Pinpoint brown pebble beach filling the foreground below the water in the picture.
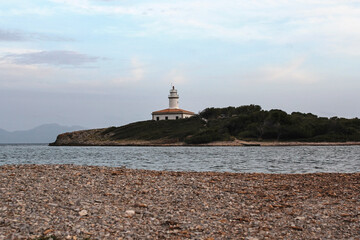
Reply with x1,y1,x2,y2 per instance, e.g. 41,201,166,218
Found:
0,165,360,240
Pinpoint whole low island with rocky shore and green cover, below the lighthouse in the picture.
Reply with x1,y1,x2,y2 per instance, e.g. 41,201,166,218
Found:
49,105,360,146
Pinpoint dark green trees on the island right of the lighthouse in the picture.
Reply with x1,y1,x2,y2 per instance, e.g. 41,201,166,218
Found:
185,105,360,144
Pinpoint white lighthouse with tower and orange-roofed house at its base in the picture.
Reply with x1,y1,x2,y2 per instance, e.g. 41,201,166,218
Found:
152,86,195,121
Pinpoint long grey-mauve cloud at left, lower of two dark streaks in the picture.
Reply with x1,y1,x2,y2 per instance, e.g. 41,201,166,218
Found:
3,51,100,67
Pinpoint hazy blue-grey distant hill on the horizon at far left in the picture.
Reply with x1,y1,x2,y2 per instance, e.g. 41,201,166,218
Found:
0,124,84,144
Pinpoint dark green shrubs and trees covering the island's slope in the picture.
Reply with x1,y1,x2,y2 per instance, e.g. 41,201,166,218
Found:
100,105,360,144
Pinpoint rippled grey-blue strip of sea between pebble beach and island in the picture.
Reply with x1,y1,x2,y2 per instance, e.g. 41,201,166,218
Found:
0,145,360,173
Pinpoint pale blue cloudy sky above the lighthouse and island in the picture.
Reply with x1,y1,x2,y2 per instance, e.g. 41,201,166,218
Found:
0,0,360,131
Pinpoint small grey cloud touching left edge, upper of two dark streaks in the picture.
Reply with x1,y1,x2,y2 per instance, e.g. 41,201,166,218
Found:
0,29,73,42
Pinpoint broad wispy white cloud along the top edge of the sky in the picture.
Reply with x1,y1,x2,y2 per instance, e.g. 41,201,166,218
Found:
52,0,360,51
